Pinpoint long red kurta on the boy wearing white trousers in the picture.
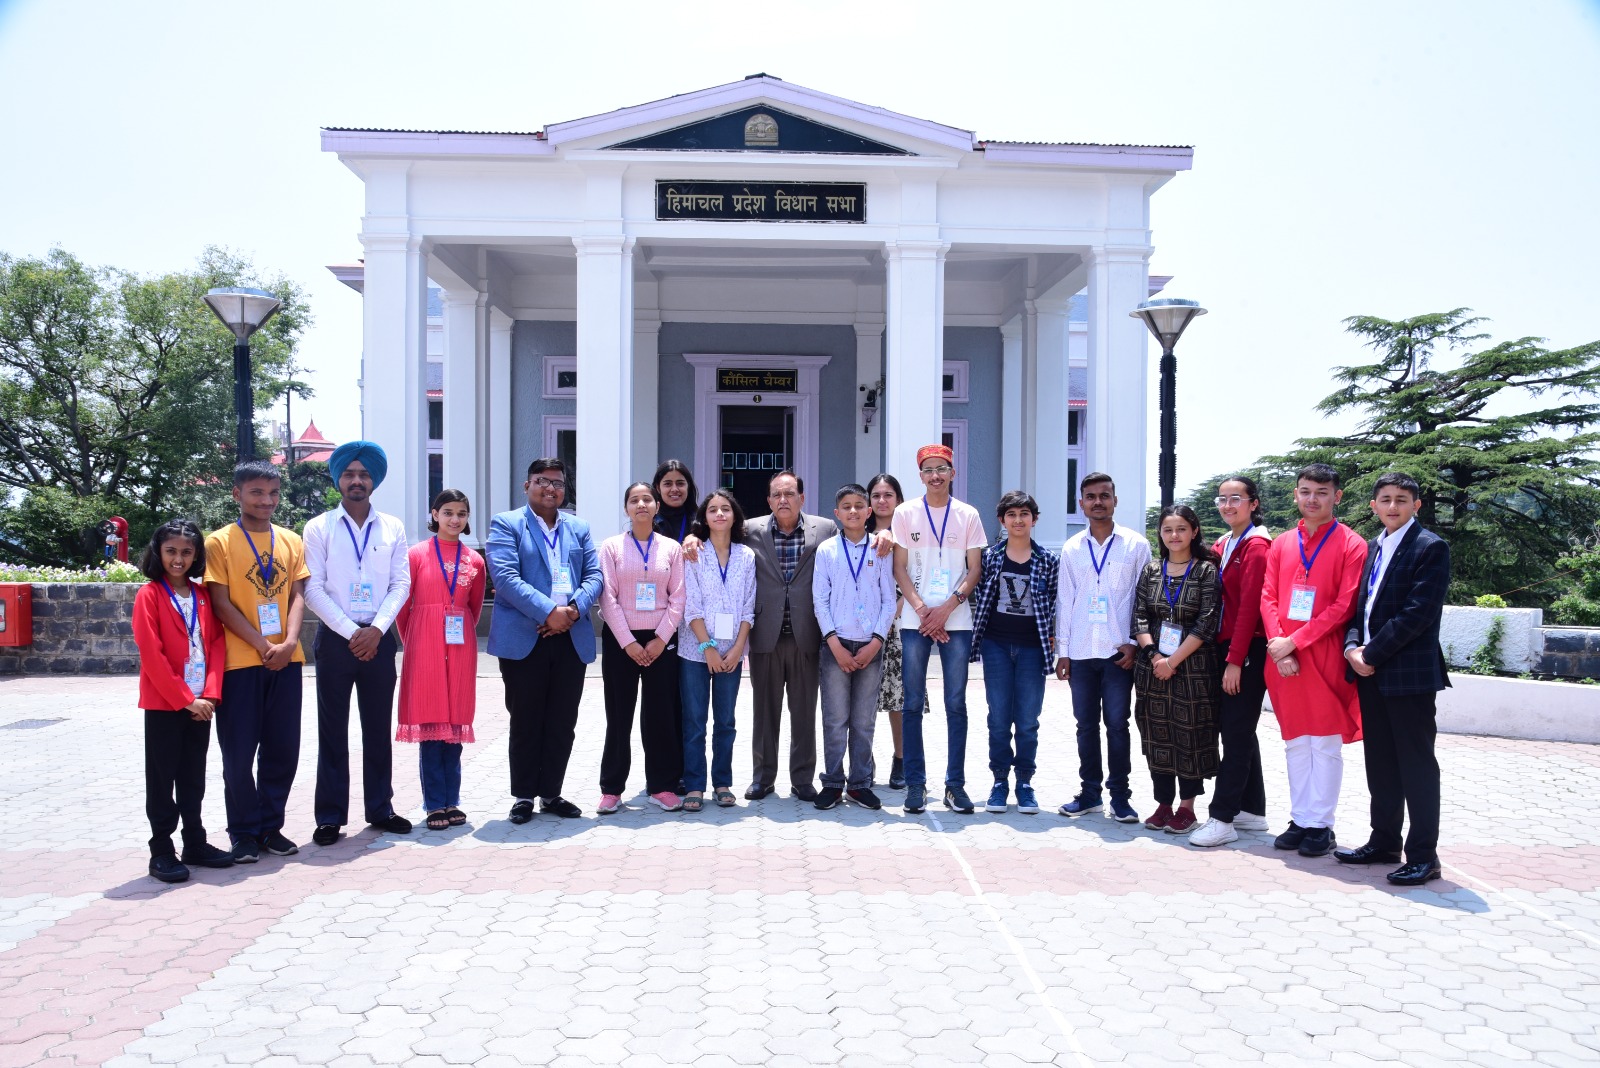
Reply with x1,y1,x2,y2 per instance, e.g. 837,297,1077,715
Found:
1261,521,1366,743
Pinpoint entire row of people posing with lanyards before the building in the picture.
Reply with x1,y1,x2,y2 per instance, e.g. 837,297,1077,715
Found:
134,441,1450,884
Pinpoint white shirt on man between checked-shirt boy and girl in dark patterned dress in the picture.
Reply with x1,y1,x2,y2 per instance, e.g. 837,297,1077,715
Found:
1056,523,1150,660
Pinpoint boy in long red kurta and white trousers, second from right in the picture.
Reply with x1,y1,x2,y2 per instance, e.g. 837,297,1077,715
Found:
1261,464,1366,857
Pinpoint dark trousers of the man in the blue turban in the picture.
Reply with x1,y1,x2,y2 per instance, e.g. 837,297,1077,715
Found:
312,625,395,827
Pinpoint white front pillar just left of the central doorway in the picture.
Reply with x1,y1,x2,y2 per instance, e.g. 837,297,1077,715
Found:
573,235,634,544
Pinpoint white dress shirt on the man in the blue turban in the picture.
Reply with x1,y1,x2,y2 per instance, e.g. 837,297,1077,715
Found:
301,504,411,638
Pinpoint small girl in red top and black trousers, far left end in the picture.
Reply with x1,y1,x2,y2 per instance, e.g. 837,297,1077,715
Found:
133,520,234,883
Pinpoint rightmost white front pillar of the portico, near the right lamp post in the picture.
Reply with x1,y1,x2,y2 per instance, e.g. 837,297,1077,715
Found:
1085,246,1155,531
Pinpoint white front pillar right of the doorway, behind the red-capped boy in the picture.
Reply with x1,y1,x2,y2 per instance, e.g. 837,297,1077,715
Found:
880,241,940,496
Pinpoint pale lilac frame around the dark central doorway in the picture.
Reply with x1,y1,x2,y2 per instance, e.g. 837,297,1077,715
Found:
683,352,832,494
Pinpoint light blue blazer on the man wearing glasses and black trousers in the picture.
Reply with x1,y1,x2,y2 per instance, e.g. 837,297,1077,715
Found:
485,505,600,664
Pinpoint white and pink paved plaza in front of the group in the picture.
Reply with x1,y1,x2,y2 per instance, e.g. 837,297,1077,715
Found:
0,671,1600,1068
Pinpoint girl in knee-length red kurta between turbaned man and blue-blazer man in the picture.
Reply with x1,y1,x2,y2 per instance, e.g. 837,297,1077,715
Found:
395,489,485,830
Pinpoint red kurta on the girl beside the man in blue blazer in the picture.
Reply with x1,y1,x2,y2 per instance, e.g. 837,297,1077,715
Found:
395,537,485,742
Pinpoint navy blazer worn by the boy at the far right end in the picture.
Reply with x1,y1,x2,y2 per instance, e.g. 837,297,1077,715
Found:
1344,523,1450,697
